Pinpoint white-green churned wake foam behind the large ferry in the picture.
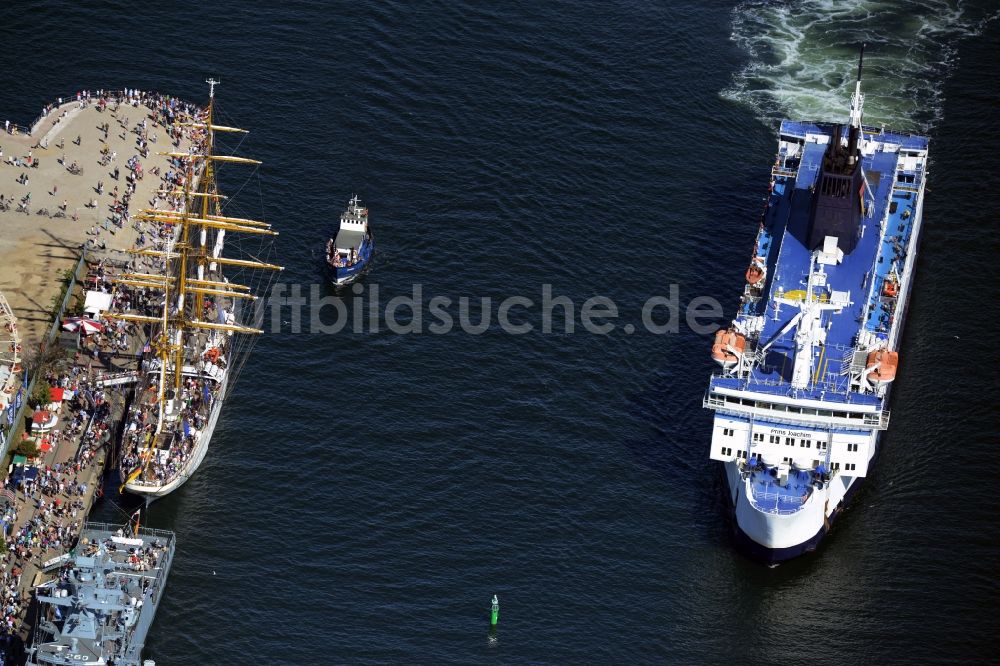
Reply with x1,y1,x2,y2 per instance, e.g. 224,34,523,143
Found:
722,0,1000,132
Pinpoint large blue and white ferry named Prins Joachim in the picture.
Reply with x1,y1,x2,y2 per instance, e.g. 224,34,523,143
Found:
704,49,928,564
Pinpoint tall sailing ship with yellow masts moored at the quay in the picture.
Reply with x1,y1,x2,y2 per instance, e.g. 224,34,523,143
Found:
109,79,282,502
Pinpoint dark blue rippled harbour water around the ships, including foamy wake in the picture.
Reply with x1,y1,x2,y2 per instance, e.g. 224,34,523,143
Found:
0,0,1000,666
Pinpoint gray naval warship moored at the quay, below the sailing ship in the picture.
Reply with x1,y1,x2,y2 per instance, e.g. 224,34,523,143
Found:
27,523,175,666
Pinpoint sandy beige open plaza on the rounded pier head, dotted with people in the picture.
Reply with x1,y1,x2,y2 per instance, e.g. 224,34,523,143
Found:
0,96,197,350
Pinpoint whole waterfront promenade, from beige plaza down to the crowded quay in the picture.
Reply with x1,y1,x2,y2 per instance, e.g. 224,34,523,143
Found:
0,94,201,652
